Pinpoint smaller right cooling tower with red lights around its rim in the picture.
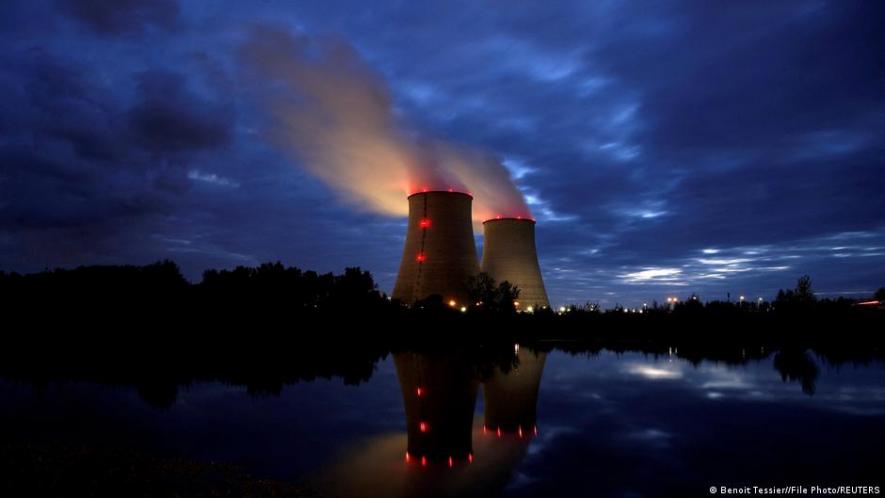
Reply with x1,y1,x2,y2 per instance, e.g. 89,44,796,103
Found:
482,218,550,309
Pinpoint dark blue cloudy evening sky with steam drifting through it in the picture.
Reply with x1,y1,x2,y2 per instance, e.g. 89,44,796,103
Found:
0,0,885,306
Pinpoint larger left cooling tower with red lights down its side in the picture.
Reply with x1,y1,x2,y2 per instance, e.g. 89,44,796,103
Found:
392,191,479,306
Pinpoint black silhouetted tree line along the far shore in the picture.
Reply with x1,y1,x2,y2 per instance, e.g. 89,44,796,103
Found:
0,260,885,323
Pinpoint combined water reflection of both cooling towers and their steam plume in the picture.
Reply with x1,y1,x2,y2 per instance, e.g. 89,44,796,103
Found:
320,347,547,497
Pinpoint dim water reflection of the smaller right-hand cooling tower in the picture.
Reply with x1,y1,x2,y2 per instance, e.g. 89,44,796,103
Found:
483,349,547,434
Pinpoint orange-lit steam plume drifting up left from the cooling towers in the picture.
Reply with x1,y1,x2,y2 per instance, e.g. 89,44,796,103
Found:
241,26,531,220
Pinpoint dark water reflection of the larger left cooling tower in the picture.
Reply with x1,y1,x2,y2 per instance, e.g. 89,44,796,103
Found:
393,353,479,462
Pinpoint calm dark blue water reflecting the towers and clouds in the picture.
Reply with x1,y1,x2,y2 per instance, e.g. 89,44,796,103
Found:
0,348,885,497
